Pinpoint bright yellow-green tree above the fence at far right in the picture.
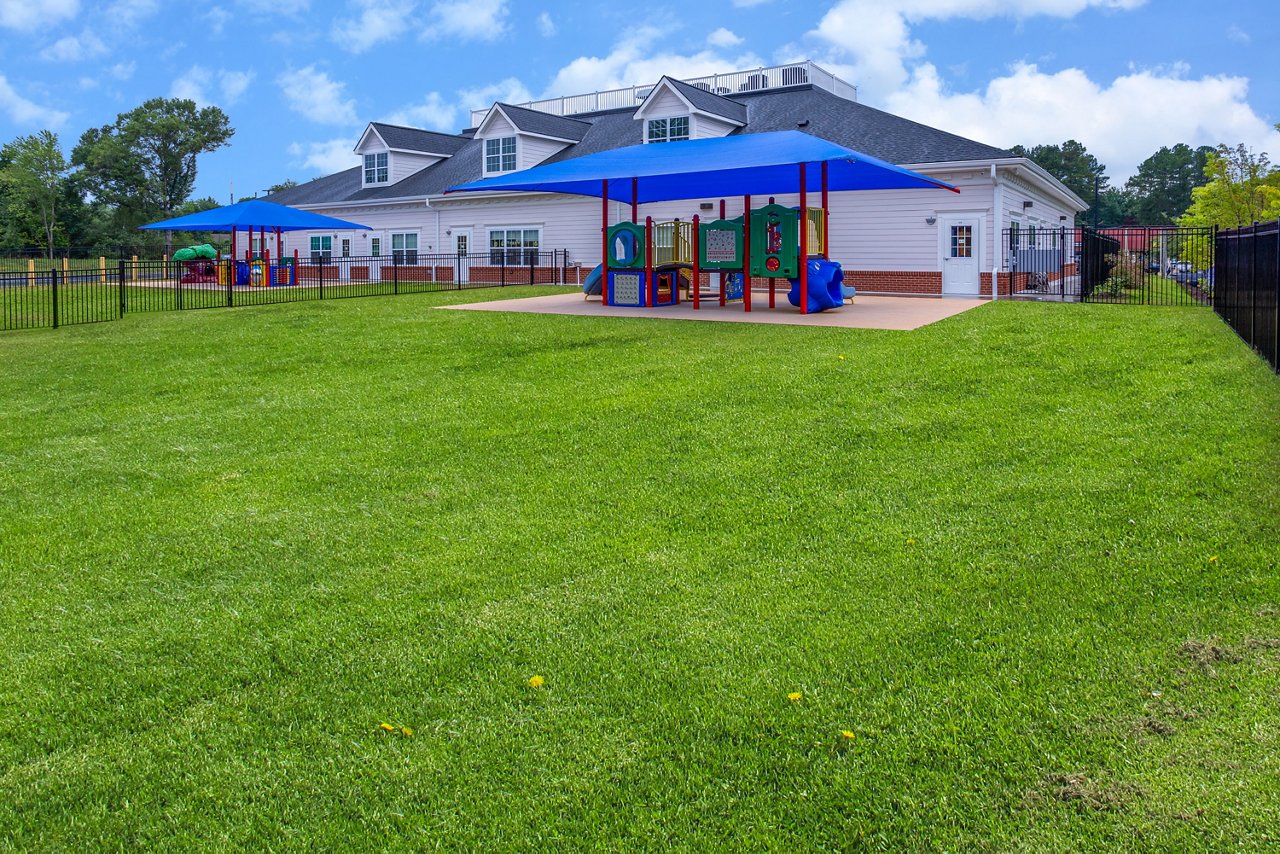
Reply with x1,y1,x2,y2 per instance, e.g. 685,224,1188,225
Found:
1178,143,1280,228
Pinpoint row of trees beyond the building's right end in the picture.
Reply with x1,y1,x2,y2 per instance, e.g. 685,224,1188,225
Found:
1011,125,1280,228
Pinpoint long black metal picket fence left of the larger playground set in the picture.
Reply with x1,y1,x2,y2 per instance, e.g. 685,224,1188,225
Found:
0,250,588,330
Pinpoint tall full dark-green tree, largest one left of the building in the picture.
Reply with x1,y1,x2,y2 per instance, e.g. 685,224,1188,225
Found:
72,97,236,248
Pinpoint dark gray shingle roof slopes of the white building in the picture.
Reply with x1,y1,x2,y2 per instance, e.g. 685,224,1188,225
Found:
268,83,1015,205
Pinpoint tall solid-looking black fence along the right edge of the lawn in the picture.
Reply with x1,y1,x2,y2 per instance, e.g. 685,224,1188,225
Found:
1213,220,1280,371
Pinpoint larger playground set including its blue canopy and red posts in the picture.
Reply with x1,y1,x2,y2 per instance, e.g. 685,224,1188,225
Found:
447,131,960,314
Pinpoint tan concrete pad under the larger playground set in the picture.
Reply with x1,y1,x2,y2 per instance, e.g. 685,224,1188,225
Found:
440,289,987,330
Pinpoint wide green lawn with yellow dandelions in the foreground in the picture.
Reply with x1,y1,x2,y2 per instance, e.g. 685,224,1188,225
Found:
0,289,1280,851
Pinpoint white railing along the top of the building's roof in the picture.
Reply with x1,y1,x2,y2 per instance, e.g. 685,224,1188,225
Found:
471,60,858,127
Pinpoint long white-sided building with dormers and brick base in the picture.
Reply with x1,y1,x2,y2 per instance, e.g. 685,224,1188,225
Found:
270,61,1087,296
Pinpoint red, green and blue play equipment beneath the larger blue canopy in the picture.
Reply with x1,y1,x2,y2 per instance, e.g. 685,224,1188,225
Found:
582,193,852,312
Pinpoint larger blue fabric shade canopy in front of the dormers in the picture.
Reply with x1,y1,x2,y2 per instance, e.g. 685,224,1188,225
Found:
447,131,960,204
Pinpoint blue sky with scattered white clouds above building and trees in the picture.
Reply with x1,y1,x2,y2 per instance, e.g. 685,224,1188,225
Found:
0,0,1280,201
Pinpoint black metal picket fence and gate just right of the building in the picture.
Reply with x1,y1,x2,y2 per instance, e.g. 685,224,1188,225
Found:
1001,225,1213,306
